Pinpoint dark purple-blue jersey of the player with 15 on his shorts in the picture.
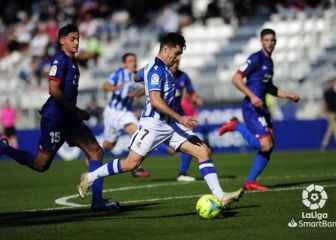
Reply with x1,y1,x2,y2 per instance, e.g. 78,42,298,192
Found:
41,51,79,121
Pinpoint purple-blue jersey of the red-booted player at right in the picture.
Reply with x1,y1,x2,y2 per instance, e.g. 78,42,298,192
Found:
239,50,277,101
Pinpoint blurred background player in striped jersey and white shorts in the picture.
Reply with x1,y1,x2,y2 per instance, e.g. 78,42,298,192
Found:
103,52,150,177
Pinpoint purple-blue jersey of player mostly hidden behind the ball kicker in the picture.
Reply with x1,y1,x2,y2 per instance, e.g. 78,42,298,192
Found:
174,70,195,115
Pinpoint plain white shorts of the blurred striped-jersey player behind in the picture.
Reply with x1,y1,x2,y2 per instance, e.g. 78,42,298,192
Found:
104,107,138,143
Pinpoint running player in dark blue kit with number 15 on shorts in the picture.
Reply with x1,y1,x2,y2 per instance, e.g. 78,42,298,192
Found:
0,24,118,211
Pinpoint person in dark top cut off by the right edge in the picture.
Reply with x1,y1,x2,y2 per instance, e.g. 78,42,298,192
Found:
321,79,336,151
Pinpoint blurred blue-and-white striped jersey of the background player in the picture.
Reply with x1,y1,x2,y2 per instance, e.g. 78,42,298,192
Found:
108,68,138,111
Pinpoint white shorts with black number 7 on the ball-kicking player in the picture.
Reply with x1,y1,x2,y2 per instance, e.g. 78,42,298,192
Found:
130,117,195,156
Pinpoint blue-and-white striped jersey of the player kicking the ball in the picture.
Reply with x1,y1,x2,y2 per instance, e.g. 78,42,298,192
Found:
141,58,176,121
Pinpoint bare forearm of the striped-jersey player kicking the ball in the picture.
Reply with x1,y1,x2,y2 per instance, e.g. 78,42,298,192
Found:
149,91,197,129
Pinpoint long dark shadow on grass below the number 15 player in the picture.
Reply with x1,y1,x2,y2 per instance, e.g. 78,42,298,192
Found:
0,203,159,228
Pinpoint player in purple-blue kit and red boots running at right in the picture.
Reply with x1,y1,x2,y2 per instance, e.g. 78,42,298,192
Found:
219,29,300,191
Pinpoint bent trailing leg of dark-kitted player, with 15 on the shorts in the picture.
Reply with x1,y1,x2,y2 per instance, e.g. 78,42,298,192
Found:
0,118,64,172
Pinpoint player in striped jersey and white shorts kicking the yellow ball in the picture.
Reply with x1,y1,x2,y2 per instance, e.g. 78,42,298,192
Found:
78,33,243,207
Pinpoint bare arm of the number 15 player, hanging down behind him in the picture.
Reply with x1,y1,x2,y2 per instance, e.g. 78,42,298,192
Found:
49,80,90,120
